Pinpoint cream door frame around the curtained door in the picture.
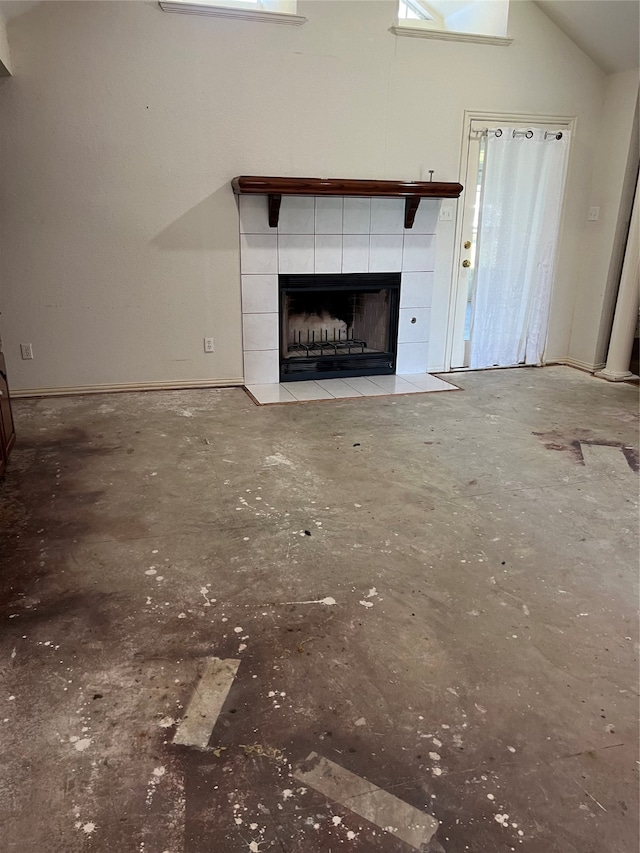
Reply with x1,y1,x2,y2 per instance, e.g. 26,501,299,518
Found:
445,110,577,372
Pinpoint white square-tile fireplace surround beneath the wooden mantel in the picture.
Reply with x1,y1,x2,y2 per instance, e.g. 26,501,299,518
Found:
238,195,440,385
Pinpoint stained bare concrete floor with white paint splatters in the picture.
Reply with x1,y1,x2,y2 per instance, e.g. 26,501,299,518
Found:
0,367,639,853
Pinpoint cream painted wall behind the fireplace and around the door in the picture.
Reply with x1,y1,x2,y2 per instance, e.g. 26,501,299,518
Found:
0,0,620,389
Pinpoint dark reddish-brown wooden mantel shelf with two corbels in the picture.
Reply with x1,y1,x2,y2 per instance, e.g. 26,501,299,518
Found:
231,175,462,228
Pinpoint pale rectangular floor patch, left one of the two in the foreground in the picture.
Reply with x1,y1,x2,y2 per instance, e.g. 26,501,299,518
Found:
173,658,240,749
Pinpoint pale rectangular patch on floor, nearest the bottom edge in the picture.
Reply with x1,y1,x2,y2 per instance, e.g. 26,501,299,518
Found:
294,752,439,850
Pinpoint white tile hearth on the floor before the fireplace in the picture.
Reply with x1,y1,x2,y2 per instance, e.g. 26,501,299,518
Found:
244,373,460,406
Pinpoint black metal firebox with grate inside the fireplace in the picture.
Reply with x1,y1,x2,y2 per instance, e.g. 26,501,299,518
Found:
279,273,400,382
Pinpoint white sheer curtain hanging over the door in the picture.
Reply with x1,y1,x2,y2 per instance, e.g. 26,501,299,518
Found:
469,127,570,368
